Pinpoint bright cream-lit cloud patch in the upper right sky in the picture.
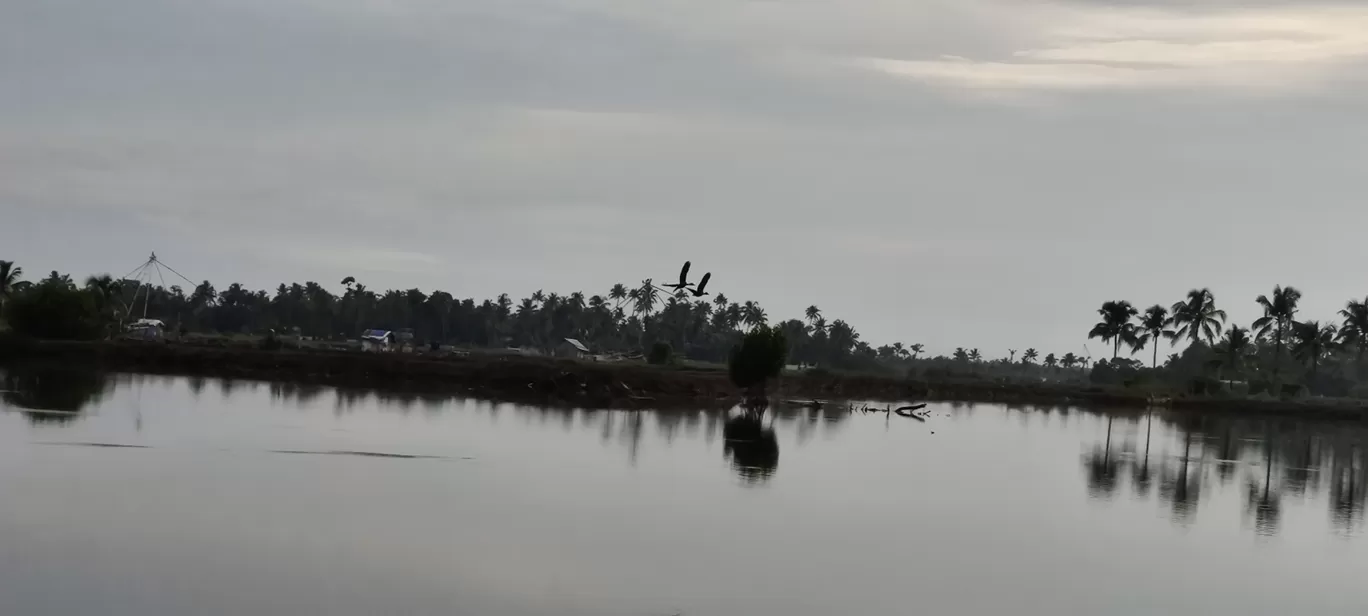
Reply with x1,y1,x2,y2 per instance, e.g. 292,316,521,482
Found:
852,4,1368,93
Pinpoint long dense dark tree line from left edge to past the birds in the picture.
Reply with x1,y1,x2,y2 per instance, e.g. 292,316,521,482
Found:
0,261,923,370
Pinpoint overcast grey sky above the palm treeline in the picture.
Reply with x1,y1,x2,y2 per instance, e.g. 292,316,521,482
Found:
0,0,1368,357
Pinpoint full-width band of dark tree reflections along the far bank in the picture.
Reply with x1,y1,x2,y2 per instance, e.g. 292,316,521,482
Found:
16,367,1368,535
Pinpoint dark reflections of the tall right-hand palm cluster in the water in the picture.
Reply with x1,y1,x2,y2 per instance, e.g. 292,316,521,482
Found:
1082,412,1368,535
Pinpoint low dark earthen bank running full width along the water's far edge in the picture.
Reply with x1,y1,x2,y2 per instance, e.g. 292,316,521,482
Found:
0,339,1368,420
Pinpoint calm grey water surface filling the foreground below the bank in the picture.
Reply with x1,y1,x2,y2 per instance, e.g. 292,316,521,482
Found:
0,366,1368,616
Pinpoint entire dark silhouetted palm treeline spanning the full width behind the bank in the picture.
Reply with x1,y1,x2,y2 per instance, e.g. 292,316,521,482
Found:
8,261,1368,397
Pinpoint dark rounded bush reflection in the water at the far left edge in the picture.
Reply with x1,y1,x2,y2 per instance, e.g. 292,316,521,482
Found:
0,365,112,426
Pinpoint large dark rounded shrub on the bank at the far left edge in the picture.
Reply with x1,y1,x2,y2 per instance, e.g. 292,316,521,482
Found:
5,285,104,339
